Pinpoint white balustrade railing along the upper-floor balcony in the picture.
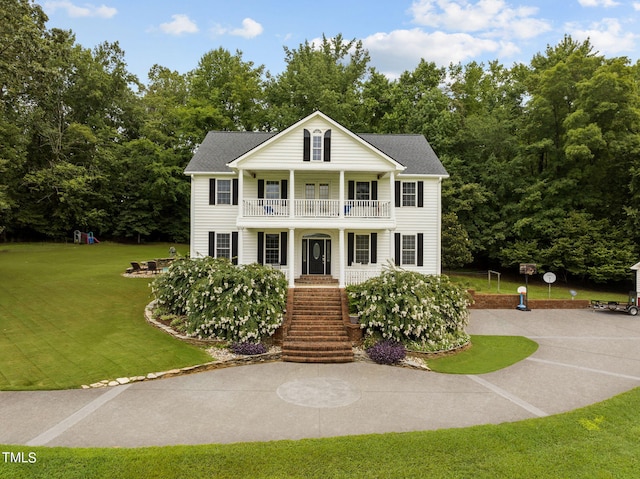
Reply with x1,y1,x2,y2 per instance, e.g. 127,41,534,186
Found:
242,199,391,219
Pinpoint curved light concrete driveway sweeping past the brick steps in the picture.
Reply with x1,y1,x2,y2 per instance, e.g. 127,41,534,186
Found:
0,310,640,447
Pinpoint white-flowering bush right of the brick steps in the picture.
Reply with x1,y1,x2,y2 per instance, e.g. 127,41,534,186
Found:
347,269,469,351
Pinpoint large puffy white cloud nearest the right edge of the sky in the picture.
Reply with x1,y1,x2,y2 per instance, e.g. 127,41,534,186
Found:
565,18,640,55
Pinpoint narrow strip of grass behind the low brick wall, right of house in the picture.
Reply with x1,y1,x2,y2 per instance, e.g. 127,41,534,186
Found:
446,272,628,301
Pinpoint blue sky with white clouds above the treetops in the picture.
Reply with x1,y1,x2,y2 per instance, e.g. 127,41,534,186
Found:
42,0,640,82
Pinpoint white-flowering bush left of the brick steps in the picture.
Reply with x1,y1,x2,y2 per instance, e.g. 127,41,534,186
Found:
152,258,287,342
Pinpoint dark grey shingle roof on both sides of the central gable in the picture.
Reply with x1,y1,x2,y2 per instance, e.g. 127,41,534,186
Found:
185,131,447,176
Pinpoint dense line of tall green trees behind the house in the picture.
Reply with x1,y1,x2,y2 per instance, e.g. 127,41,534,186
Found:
0,0,640,281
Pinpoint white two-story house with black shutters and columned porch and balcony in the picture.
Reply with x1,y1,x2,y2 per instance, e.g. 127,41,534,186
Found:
185,112,448,287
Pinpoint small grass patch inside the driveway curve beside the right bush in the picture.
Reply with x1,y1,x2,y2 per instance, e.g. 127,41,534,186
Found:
427,335,538,374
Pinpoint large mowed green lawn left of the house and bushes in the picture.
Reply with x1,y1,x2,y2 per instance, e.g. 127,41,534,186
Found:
0,243,210,390
